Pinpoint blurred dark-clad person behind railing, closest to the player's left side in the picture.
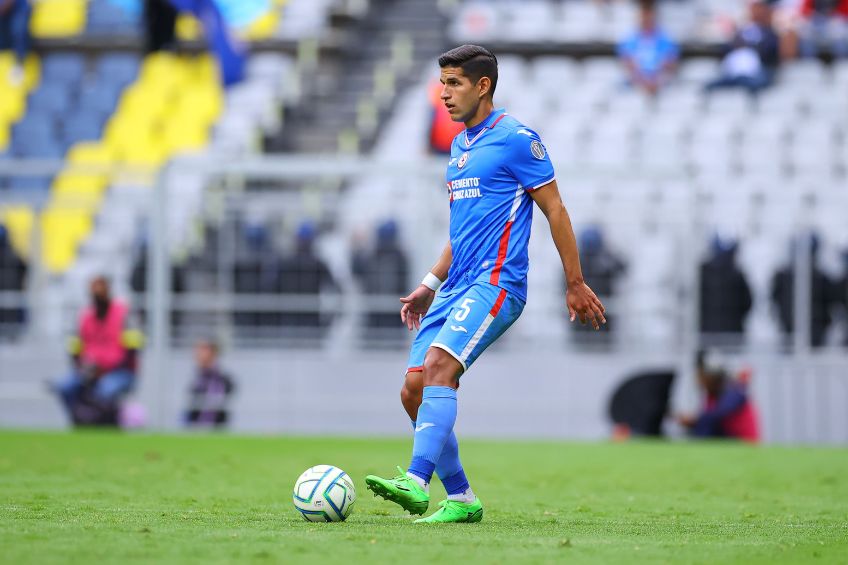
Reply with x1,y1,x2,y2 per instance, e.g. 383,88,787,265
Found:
353,220,409,335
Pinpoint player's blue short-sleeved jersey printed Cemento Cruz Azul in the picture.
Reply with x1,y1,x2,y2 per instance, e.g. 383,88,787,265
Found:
442,110,554,301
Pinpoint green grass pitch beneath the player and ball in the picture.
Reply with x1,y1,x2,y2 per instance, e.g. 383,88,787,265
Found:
0,432,848,564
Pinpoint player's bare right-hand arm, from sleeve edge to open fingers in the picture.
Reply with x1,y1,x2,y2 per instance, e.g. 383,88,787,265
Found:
530,180,607,330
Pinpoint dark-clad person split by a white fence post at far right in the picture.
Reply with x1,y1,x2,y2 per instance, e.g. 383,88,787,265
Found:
771,231,839,347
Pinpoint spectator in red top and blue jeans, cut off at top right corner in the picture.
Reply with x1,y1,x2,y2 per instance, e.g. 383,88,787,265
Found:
798,0,848,58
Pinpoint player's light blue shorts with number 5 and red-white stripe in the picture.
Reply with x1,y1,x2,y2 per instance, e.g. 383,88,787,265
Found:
406,282,524,373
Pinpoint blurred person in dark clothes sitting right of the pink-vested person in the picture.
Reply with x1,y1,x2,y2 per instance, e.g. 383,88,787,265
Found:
185,339,235,428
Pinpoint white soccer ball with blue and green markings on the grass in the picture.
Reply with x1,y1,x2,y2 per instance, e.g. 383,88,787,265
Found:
292,465,356,522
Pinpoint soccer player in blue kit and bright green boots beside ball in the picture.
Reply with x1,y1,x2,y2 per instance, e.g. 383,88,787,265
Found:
365,45,606,522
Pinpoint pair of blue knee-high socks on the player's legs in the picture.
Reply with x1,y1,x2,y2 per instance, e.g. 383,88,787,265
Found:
409,386,468,494
